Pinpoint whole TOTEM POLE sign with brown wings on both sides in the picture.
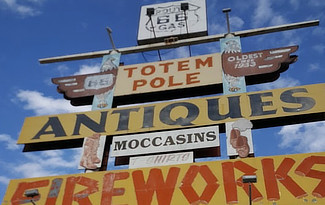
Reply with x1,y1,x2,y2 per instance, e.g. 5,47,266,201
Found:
52,46,298,107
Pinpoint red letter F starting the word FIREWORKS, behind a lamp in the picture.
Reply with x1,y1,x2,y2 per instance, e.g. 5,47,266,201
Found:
11,180,50,205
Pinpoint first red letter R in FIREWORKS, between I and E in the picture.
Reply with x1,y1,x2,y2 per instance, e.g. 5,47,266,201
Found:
63,176,98,205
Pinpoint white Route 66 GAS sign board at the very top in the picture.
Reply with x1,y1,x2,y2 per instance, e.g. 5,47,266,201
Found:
138,0,208,45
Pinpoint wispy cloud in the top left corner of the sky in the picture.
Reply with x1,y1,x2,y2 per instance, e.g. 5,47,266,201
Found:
0,0,41,16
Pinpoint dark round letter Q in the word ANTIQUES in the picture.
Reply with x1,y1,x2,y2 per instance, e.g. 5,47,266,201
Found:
159,102,200,126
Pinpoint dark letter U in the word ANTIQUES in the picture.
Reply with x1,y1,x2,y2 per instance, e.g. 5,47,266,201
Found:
207,96,242,121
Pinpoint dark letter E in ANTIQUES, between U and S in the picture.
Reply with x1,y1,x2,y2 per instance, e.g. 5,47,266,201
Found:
248,92,276,116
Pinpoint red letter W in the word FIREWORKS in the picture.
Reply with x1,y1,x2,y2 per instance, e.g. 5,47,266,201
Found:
132,167,180,205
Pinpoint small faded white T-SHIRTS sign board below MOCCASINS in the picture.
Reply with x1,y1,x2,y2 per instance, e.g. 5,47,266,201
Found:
129,152,193,169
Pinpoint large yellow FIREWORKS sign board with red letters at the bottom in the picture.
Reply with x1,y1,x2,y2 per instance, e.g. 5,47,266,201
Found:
2,152,325,205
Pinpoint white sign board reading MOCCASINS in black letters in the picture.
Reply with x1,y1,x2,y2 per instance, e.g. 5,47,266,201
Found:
111,126,220,157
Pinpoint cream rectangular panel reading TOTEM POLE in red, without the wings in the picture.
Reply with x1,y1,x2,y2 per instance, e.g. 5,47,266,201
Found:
114,53,222,96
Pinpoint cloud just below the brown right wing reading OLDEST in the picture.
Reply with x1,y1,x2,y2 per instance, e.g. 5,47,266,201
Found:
248,76,300,91
